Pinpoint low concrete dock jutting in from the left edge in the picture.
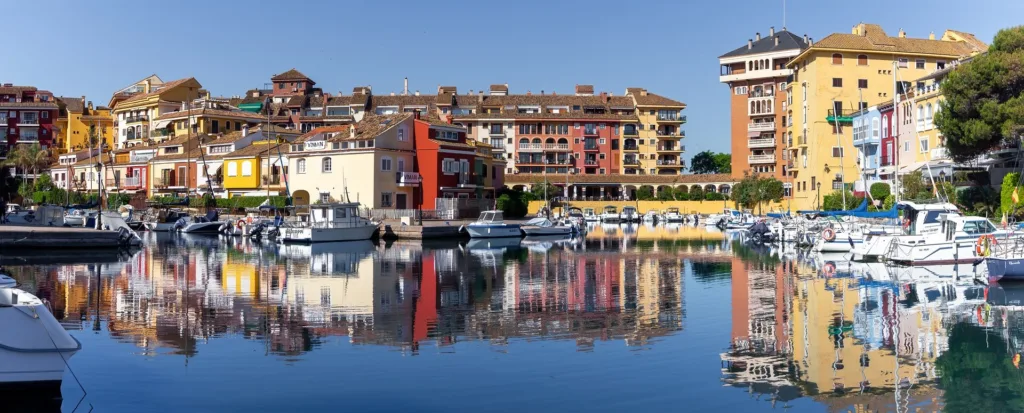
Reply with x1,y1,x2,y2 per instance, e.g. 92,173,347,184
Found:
0,224,121,249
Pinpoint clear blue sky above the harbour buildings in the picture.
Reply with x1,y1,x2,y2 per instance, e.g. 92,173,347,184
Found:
6,0,1024,164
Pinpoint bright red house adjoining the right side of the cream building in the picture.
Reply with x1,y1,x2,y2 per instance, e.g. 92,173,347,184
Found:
413,113,479,209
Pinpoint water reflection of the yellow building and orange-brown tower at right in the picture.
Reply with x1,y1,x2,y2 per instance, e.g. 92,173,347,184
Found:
722,254,958,411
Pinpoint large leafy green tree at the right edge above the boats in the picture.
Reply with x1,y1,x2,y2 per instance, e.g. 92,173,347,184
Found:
935,26,1024,161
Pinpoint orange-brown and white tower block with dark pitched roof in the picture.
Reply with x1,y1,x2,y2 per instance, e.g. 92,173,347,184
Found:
718,27,807,185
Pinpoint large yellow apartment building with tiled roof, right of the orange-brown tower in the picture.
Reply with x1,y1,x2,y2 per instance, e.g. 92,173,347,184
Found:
786,24,985,209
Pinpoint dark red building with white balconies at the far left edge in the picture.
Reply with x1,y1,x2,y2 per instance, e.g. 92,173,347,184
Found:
0,83,58,154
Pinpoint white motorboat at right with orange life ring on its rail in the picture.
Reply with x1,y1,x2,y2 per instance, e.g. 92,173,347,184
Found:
886,214,1020,265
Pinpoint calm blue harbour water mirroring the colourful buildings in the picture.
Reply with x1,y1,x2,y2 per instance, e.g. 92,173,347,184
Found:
6,225,1024,412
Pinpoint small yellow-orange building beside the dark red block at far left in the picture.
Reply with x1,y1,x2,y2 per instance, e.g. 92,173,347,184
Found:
54,96,116,153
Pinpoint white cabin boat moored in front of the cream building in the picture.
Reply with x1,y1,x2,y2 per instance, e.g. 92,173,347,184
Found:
279,203,379,242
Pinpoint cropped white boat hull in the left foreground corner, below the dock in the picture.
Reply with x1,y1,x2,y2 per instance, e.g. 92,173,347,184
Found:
0,287,82,393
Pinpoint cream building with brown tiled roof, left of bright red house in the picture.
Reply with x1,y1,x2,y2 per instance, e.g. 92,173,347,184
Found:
288,113,416,209
